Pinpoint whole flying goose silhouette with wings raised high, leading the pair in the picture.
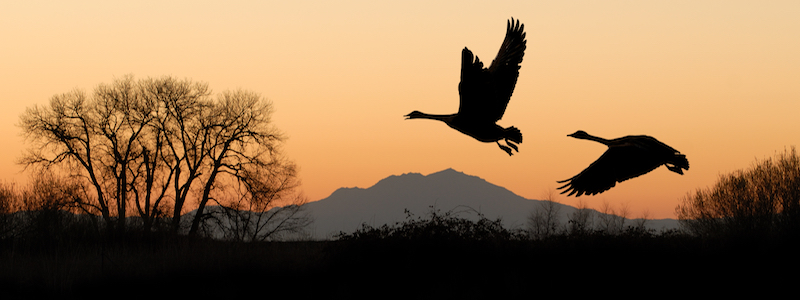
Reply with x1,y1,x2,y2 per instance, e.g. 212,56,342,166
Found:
405,18,526,155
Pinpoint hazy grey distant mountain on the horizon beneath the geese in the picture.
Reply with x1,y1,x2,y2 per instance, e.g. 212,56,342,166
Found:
305,169,678,239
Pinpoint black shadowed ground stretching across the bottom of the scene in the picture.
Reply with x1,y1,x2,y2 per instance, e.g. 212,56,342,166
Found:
0,235,798,299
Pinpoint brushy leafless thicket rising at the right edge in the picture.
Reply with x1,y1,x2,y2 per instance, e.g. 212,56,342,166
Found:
676,147,800,236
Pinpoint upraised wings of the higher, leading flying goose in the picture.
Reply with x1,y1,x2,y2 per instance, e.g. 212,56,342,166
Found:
458,18,526,123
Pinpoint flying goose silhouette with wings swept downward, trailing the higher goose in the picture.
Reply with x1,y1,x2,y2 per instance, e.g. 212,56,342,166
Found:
558,130,689,197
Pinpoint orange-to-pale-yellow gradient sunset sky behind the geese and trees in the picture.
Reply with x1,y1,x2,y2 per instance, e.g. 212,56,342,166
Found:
0,0,800,218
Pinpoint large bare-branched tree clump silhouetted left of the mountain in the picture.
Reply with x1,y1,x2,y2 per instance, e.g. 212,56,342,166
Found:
10,75,308,240
